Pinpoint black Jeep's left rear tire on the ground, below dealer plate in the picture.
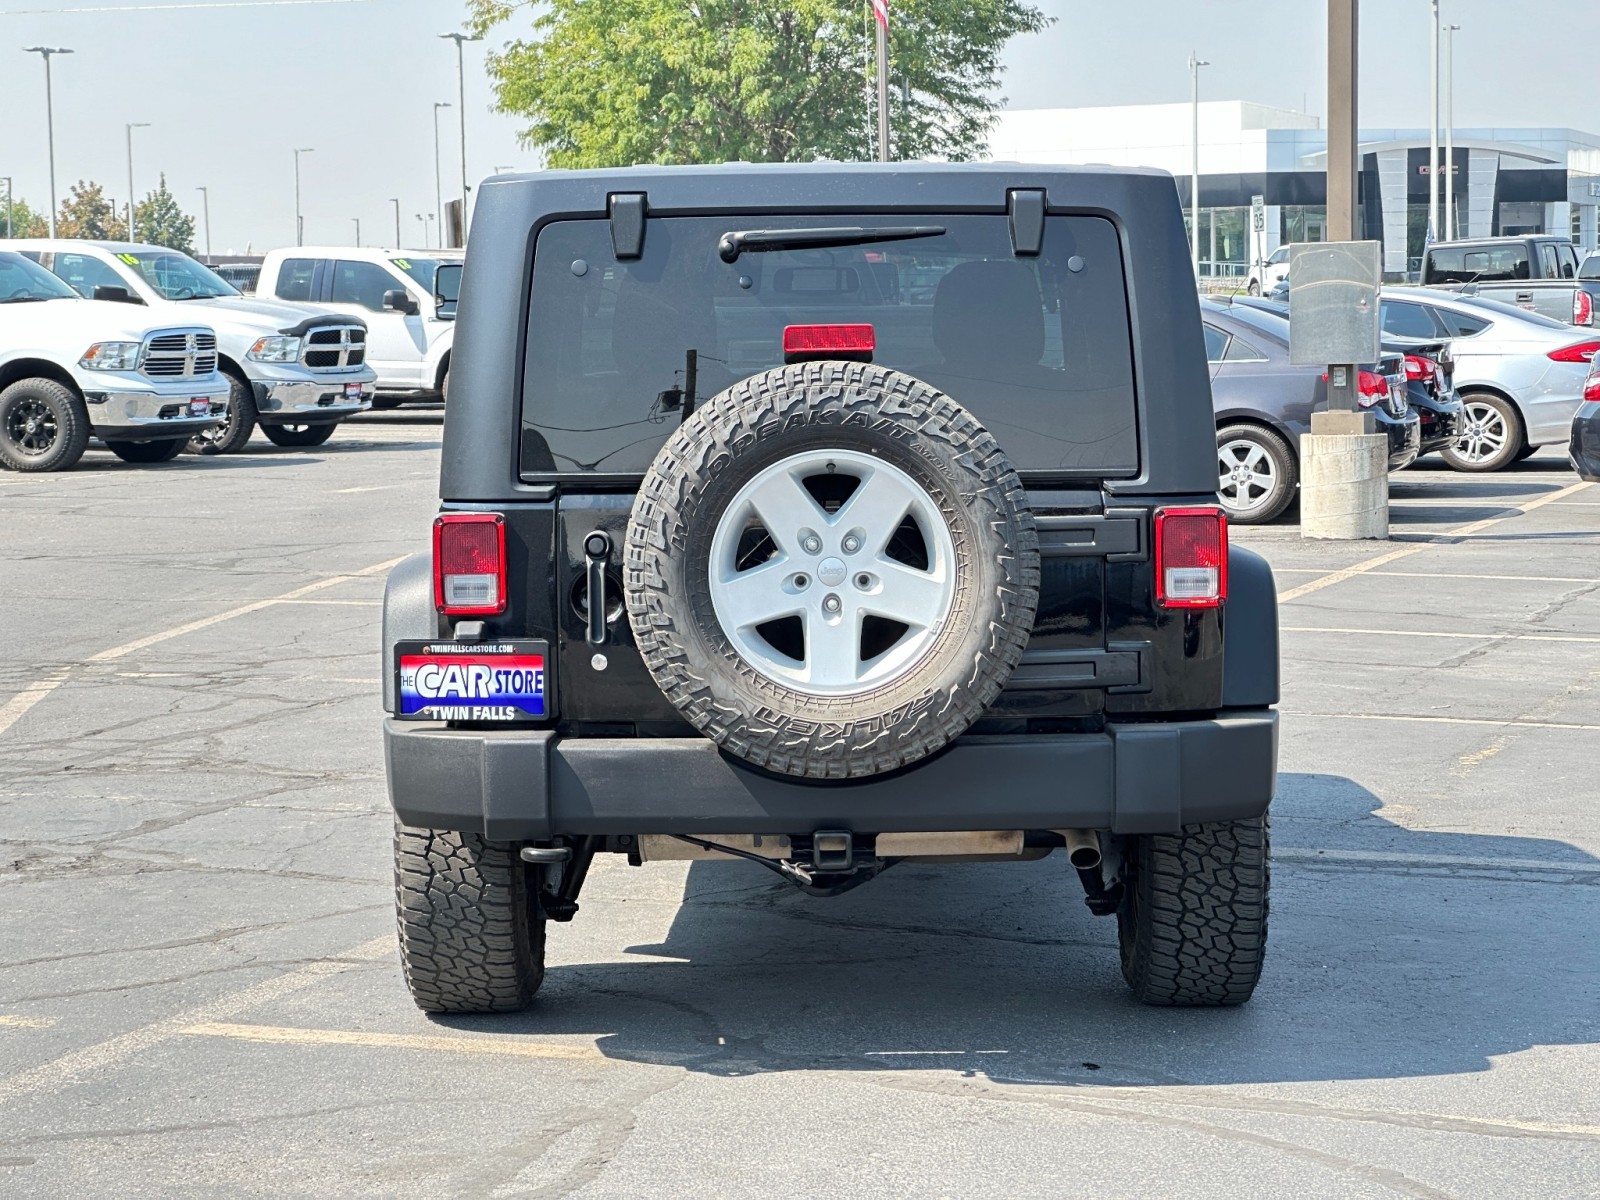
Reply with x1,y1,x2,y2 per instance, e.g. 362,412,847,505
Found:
395,824,544,1013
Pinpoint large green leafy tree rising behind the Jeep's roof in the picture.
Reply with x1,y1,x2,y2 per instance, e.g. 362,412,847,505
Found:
469,0,1050,166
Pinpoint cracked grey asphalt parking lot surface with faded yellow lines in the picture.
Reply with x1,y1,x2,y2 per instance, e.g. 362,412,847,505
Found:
0,414,1600,1197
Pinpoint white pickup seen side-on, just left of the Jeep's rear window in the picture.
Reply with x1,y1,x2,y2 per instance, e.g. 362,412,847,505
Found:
256,246,461,408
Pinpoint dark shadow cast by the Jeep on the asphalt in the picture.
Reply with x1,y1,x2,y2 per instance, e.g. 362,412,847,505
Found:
445,774,1600,1086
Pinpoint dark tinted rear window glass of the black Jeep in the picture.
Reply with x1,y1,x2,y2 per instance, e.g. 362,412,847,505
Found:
522,213,1138,477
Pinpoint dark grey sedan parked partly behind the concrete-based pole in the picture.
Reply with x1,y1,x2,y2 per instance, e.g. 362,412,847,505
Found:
1200,301,1422,525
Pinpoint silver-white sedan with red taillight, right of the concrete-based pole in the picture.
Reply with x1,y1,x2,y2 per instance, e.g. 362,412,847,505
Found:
1382,288,1600,470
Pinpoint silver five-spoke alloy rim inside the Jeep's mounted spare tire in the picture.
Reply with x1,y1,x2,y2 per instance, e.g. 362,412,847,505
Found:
709,450,955,696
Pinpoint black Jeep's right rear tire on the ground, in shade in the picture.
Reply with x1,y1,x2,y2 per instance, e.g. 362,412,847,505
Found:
1117,816,1270,1006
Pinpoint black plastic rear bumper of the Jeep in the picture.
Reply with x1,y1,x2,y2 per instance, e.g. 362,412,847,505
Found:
384,709,1278,842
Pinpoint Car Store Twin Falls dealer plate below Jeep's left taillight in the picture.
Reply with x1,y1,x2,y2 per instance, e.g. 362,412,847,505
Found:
395,642,549,722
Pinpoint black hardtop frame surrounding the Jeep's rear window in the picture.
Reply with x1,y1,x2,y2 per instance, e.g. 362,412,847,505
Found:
440,163,1216,504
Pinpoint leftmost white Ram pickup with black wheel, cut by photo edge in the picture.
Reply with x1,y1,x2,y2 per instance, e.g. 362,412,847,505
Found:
0,251,227,470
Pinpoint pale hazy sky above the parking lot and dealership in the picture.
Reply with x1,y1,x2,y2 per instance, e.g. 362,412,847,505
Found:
0,0,1600,253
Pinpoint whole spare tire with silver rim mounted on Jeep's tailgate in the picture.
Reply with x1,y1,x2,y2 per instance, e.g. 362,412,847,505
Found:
626,362,1038,779
